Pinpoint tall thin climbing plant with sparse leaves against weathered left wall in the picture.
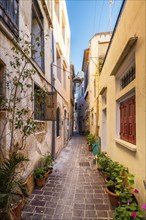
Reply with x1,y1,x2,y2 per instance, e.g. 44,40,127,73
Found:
0,32,40,160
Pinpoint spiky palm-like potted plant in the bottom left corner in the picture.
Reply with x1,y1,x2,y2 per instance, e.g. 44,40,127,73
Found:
0,153,28,220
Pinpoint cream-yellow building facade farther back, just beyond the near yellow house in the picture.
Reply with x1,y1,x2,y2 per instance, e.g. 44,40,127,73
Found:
88,32,111,136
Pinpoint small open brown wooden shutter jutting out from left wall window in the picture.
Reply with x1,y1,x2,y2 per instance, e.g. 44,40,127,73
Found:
45,92,57,121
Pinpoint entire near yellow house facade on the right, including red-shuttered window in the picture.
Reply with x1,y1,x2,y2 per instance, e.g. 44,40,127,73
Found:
98,1,146,203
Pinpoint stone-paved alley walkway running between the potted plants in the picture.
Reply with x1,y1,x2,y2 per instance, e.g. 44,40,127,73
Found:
22,135,112,220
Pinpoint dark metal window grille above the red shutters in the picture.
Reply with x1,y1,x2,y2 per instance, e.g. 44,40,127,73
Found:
121,66,135,89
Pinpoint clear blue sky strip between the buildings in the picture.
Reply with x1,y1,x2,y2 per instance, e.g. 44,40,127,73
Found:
66,0,123,73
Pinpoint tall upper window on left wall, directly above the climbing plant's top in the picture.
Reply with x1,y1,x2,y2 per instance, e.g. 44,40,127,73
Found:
31,0,44,69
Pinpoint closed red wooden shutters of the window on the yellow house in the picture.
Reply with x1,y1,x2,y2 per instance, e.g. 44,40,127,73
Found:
120,96,136,144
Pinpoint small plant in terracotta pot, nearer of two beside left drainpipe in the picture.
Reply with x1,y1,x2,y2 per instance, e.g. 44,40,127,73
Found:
34,167,45,187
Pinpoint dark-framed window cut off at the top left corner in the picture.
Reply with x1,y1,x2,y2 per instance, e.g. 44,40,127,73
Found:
0,0,19,37
